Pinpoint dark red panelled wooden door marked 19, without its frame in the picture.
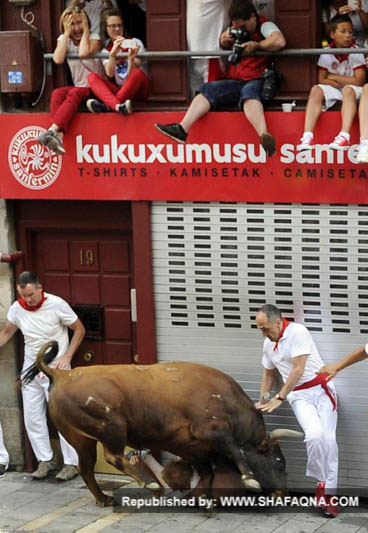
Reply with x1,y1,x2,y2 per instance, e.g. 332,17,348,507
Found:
34,229,136,366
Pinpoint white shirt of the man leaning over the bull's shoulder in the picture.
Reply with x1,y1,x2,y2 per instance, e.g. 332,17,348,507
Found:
262,322,324,386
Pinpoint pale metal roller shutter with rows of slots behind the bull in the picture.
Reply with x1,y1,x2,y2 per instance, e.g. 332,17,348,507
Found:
152,202,368,490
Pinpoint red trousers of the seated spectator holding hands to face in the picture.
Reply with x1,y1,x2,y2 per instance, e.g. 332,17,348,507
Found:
50,85,92,132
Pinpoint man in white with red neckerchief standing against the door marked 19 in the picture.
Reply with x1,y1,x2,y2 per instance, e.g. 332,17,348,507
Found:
0,272,85,481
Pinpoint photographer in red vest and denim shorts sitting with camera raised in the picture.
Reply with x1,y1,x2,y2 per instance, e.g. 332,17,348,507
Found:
155,0,285,156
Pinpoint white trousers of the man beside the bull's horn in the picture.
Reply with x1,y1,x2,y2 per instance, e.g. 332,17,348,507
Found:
287,381,339,494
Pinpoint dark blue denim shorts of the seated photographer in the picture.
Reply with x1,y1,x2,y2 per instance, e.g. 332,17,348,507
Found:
199,78,263,109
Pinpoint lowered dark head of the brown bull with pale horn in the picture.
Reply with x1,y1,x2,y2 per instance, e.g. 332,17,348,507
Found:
244,429,304,496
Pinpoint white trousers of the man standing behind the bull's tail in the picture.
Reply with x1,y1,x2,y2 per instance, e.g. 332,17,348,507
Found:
22,372,78,466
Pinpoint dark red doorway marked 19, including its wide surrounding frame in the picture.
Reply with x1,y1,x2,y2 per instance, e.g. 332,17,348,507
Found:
13,200,156,471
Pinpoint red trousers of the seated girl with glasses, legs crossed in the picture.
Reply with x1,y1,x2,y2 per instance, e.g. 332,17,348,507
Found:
88,68,149,111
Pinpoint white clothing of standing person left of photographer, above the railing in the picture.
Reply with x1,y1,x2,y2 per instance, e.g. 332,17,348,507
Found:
187,0,232,52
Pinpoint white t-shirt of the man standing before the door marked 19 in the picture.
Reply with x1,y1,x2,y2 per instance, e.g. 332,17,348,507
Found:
7,292,78,366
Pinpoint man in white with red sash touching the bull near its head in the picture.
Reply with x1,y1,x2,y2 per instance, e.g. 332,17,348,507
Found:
256,304,338,517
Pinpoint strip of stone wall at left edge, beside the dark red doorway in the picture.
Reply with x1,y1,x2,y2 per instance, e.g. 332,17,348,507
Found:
0,200,25,470
